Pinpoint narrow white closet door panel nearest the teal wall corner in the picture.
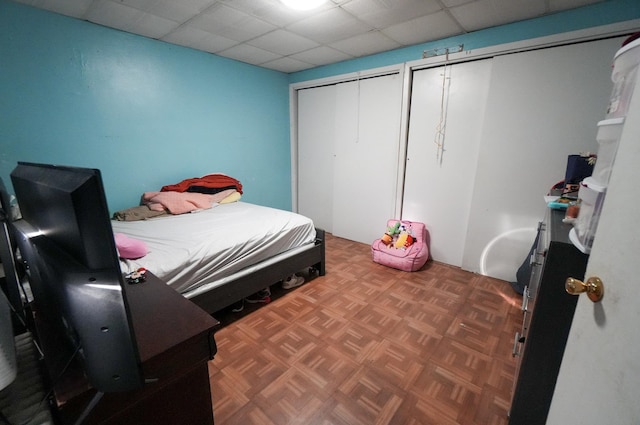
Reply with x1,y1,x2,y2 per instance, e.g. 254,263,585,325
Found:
297,85,336,233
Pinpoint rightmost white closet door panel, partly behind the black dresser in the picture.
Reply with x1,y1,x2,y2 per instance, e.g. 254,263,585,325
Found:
462,39,621,280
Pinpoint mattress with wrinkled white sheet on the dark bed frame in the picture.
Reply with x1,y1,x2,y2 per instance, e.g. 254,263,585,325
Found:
112,202,316,294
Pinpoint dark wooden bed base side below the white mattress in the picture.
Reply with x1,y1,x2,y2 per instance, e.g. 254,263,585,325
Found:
189,229,325,314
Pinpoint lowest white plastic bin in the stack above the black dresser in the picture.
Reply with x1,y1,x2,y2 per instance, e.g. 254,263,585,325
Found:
569,177,607,253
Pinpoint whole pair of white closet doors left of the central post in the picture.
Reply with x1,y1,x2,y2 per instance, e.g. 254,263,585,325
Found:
298,73,402,244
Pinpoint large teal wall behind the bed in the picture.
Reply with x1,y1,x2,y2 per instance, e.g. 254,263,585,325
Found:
0,0,291,212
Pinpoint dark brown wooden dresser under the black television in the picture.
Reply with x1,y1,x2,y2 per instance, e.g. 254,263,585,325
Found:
43,273,219,425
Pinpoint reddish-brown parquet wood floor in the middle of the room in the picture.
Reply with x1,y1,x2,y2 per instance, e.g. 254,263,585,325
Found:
209,235,522,425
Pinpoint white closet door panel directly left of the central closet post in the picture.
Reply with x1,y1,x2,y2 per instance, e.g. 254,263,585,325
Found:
333,74,402,244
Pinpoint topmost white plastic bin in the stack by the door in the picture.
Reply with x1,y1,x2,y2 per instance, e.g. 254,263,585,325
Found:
607,39,640,118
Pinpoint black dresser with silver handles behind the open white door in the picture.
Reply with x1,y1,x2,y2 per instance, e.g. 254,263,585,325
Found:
509,209,588,425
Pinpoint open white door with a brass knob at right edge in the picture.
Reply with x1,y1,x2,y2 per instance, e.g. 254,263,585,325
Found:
547,70,640,425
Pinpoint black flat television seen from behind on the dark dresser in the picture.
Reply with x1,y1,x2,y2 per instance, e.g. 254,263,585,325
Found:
11,162,143,393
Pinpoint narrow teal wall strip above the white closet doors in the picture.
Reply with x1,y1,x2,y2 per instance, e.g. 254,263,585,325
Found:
290,0,640,83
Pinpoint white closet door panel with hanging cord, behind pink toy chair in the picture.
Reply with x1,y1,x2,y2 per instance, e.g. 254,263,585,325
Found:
402,59,492,266
